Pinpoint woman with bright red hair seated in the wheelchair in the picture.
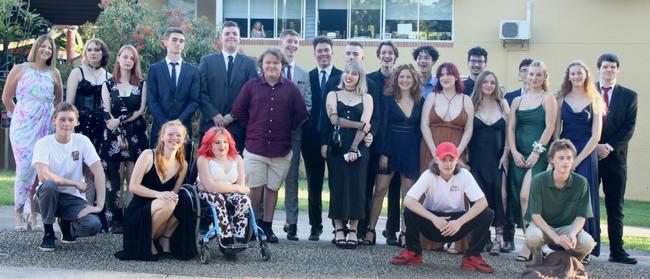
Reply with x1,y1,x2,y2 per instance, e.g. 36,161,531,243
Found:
196,127,251,260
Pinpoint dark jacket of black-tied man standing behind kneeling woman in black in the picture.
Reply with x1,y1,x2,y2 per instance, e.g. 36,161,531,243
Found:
147,59,201,143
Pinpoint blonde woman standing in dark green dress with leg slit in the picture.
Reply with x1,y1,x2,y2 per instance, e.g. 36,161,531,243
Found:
507,60,557,261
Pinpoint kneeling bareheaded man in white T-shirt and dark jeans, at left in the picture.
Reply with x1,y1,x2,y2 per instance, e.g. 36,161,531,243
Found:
32,102,106,251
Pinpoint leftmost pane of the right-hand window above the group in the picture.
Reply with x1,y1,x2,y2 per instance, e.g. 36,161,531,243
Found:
317,0,348,39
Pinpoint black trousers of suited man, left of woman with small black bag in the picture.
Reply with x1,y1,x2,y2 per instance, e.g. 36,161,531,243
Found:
301,127,325,228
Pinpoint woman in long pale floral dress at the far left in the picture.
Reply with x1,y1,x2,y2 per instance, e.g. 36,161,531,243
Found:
2,34,63,231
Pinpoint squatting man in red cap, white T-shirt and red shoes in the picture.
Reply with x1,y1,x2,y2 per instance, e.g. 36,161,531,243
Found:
390,142,494,273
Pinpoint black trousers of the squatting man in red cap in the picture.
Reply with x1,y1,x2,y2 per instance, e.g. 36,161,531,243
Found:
404,207,494,256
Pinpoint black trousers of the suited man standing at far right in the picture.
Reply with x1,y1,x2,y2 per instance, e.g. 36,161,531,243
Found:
598,158,627,252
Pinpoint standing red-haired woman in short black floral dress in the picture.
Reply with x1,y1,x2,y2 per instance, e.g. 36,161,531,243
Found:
99,45,149,233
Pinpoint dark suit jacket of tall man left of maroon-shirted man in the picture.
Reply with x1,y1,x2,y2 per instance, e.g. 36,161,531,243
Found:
199,53,258,135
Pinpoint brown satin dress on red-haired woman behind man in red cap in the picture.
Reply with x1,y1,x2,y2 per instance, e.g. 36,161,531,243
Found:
420,93,470,253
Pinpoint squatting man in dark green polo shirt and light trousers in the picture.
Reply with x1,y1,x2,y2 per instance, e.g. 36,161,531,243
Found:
526,139,596,266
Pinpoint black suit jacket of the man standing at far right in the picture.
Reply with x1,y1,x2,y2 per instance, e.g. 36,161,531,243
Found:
596,83,637,164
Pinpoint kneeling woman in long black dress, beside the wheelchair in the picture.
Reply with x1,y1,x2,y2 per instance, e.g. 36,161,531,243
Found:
115,120,187,261
